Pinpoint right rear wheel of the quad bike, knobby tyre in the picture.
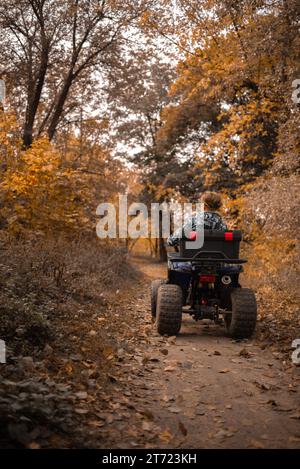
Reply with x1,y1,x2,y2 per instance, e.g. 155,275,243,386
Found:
225,288,257,339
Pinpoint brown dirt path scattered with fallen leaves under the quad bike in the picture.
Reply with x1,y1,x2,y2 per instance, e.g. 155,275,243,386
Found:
94,260,300,448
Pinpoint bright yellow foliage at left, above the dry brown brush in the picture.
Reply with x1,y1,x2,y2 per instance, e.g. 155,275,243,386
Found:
0,114,123,235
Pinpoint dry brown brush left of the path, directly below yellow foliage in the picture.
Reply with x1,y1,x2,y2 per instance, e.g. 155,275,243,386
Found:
0,239,134,354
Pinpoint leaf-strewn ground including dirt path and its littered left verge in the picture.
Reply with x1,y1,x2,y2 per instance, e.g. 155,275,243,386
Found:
0,257,300,449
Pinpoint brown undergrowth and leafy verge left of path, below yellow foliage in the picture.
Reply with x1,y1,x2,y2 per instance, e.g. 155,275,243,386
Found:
0,238,136,448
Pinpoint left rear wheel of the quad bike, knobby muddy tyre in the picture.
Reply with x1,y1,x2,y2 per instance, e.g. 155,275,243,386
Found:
156,284,182,335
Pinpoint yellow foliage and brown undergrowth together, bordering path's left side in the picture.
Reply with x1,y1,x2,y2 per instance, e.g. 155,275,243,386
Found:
0,111,135,447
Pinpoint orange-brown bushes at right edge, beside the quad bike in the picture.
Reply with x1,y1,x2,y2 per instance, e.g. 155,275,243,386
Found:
229,168,300,353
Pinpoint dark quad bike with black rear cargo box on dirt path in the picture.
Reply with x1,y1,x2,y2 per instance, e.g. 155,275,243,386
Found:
151,230,257,339
